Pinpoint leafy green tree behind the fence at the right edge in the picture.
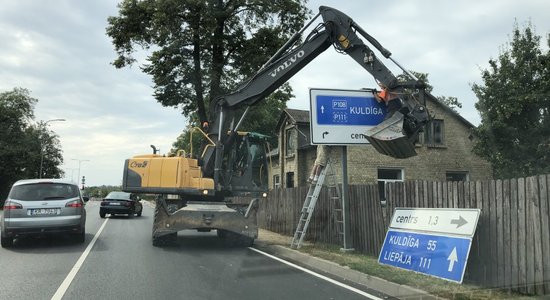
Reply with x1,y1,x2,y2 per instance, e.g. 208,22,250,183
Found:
472,24,550,178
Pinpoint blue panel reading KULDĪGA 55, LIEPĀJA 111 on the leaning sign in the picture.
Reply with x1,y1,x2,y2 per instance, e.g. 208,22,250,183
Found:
378,229,472,283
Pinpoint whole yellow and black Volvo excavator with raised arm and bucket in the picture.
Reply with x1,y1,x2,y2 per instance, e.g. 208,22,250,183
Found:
123,6,430,246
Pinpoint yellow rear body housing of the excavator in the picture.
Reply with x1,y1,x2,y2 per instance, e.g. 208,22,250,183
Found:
122,154,214,196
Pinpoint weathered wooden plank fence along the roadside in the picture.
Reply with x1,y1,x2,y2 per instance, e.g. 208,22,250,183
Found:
246,175,550,295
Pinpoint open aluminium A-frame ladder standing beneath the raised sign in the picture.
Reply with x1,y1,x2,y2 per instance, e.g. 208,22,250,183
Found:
290,161,343,249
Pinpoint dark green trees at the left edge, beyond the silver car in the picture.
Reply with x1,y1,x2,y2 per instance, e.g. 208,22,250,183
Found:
0,88,63,199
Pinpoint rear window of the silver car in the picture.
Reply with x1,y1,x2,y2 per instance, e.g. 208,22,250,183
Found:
8,183,79,201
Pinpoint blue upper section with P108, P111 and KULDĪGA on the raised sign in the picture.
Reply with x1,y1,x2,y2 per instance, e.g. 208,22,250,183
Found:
315,94,386,126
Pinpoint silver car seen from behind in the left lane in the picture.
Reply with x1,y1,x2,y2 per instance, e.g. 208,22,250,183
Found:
0,179,87,247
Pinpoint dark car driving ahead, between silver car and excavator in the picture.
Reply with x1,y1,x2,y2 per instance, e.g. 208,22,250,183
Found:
99,192,143,218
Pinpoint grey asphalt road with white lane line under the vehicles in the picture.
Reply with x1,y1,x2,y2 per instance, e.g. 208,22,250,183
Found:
0,202,384,299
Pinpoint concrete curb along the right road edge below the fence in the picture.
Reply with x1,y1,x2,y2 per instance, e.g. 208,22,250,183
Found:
254,240,444,300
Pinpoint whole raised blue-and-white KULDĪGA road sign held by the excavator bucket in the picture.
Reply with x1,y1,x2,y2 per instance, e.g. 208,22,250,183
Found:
310,89,386,145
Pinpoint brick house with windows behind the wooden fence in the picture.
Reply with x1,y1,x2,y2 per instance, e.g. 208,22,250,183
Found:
269,97,492,188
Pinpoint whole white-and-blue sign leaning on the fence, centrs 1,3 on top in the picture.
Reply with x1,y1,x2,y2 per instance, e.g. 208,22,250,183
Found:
378,208,481,283
